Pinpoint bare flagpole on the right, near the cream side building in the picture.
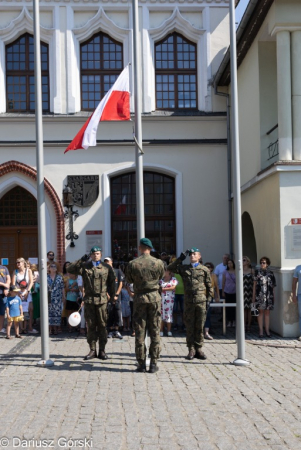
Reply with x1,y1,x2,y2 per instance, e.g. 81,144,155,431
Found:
229,0,249,366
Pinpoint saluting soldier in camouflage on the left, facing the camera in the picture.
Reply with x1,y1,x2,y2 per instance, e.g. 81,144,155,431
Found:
67,247,115,361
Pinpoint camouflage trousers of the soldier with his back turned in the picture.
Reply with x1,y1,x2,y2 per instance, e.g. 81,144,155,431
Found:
133,301,161,364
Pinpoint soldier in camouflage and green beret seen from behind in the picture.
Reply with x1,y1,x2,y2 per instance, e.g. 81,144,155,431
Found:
125,238,164,373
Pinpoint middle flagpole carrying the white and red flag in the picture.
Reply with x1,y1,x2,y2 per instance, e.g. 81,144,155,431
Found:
132,0,145,249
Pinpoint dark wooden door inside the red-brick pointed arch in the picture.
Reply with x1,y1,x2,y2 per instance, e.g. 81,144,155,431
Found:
0,186,38,273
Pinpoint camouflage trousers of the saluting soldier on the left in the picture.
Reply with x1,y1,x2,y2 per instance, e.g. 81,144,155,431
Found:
85,303,108,350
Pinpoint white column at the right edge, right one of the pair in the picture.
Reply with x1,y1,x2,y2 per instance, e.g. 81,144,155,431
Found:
292,30,301,161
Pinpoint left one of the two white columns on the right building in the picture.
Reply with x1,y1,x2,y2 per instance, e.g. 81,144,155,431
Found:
277,31,293,161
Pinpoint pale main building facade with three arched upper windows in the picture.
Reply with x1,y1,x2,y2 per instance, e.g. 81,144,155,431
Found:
0,0,229,269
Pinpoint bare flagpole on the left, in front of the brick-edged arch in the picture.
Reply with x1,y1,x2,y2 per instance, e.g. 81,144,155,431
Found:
33,0,54,367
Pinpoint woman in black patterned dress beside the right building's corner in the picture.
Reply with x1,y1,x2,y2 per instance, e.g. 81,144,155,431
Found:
253,256,276,338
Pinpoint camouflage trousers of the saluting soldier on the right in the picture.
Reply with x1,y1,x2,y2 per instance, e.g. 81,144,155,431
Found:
184,301,206,350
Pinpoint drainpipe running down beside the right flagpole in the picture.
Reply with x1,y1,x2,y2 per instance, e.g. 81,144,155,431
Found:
214,84,233,258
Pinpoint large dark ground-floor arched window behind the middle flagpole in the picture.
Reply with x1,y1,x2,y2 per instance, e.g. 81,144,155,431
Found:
111,171,176,261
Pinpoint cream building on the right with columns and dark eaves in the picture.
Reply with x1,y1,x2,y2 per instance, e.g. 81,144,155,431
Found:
215,0,301,337
